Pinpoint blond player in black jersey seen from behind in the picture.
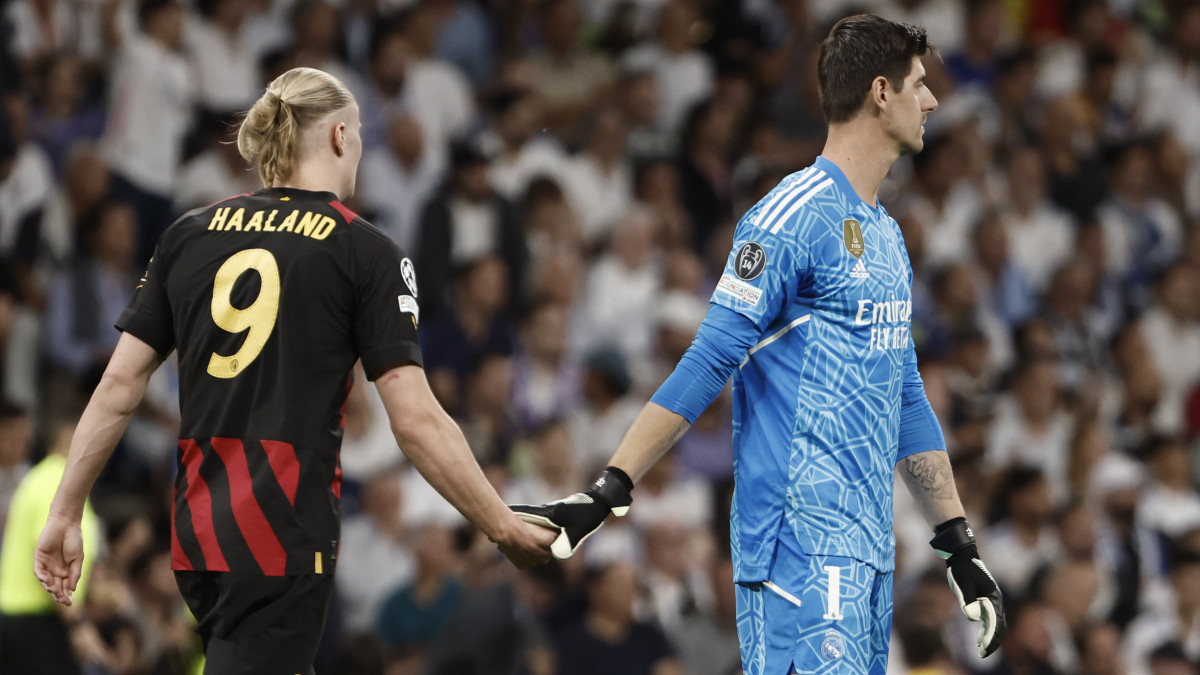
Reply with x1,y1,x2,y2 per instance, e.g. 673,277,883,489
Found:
35,68,554,675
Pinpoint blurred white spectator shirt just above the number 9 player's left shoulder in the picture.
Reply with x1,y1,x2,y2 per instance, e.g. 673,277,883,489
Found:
103,34,192,197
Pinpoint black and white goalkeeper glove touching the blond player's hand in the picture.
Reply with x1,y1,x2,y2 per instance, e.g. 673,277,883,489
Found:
509,466,634,560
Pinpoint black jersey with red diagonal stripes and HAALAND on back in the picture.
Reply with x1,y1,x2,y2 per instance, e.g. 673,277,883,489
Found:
116,189,421,575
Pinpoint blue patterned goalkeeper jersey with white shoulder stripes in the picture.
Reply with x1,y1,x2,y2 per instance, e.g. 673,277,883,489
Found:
712,157,946,583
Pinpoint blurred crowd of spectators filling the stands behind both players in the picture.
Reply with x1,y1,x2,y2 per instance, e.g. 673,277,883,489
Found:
0,0,1200,675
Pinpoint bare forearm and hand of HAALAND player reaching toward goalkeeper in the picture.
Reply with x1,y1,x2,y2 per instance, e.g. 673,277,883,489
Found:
376,365,554,566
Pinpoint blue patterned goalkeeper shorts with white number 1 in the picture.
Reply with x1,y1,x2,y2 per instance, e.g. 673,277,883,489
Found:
737,555,892,675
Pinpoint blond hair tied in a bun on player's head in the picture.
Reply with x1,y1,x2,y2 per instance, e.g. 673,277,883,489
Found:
238,67,354,187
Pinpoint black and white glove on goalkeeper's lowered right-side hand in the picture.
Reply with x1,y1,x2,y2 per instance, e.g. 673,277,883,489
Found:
929,518,1006,657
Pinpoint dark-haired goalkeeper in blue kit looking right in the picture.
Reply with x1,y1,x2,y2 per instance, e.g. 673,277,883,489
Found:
512,14,1004,675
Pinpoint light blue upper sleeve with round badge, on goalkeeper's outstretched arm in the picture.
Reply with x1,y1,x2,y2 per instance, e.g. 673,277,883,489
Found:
712,218,808,331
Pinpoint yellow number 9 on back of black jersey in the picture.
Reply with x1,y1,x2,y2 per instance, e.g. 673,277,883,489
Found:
209,249,280,380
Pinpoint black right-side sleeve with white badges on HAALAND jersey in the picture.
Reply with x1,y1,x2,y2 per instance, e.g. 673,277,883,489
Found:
350,226,421,381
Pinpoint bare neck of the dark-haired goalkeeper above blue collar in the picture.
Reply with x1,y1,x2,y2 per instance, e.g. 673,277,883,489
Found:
821,120,900,207
